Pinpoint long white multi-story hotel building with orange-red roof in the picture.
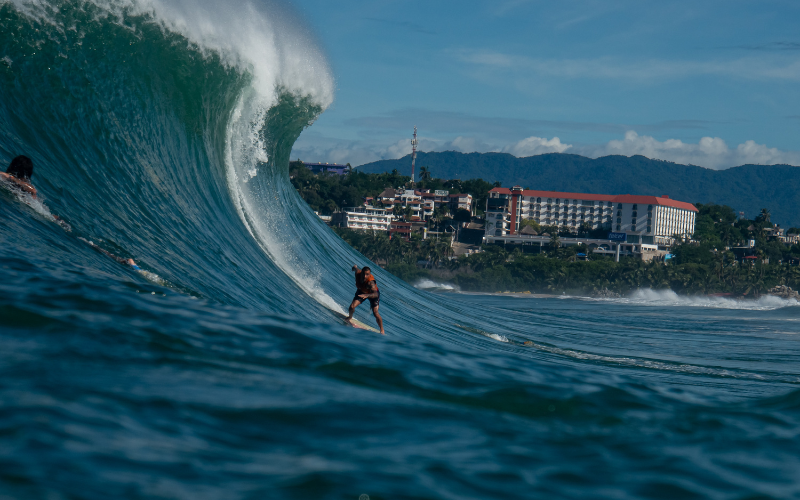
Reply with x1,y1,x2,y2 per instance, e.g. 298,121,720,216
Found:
485,186,697,245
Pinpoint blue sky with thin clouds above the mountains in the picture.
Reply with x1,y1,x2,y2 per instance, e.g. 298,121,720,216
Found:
292,0,800,168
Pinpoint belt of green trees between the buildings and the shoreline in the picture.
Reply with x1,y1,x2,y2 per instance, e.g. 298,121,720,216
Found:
336,196,800,297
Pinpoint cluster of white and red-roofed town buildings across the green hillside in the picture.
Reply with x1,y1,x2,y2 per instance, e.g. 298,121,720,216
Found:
296,163,800,263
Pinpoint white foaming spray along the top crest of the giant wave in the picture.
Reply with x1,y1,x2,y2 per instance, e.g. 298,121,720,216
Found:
8,0,334,109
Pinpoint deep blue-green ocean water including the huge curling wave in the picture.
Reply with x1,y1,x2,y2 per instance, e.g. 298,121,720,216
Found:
0,1,800,500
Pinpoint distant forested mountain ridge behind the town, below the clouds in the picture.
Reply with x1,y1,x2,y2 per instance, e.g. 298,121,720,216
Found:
358,151,800,228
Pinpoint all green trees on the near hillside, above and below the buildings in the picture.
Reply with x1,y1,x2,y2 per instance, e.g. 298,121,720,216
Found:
291,164,800,296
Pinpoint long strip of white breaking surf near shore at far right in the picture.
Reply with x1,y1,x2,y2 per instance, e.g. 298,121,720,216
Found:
599,288,800,311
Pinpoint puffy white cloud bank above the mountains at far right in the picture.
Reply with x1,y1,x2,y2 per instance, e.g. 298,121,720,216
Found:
576,130,800,169
